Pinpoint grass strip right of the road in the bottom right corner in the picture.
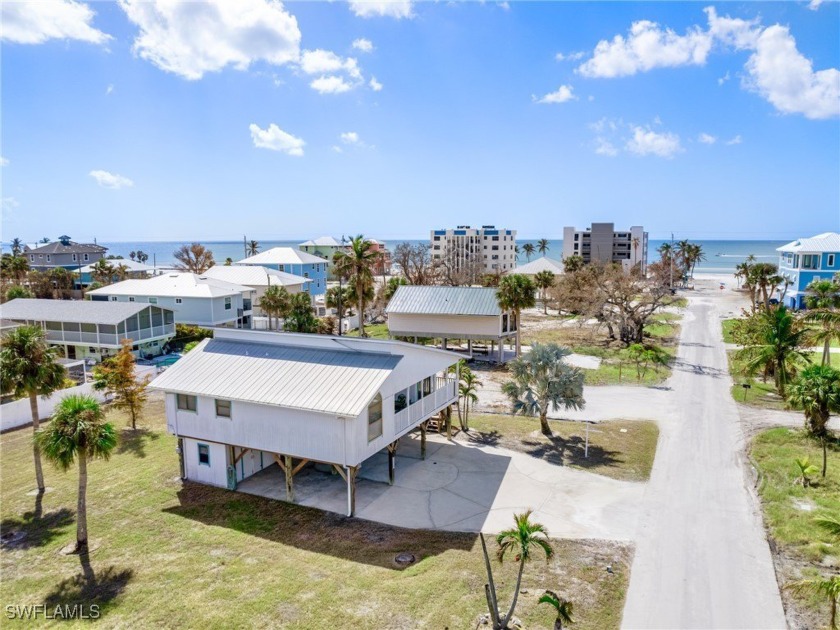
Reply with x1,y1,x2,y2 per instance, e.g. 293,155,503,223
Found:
751,428,840,628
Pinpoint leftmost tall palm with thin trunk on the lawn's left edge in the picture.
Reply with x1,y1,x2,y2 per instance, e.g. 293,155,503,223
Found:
0,326,65,493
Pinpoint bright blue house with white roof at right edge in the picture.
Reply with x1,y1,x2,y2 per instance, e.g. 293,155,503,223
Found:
776,232,840,308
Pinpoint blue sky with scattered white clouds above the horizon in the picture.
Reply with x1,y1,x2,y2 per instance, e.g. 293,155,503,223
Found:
0,0,840,241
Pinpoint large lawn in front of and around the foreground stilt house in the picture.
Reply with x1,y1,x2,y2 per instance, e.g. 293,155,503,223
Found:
0,396,632,629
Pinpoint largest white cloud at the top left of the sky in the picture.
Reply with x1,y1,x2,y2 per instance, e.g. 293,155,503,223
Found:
119,0,301,80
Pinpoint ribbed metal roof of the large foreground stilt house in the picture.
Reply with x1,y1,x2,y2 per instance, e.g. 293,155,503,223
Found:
152,339,402,417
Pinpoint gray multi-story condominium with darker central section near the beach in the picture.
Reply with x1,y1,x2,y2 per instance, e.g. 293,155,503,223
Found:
563,223,648,273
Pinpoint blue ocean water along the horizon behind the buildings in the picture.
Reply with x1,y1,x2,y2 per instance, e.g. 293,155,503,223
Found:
2,236,795,273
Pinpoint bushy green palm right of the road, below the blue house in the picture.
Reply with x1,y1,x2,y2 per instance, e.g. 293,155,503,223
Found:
735,305,809,396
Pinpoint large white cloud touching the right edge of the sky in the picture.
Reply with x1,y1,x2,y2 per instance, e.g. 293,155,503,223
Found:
745,24,840,119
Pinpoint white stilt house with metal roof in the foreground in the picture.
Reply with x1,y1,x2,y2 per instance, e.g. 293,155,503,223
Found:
146,330,458,515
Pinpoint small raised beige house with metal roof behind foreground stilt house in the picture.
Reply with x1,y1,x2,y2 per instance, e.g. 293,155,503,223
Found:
385,286,516,363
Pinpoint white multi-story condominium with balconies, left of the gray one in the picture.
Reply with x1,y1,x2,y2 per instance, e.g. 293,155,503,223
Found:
431,225,516,275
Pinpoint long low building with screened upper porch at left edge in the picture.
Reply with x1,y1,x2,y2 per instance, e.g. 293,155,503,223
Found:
0,298,175,361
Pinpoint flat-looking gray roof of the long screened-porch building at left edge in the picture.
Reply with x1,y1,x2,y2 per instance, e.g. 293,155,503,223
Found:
0,298,167,326
